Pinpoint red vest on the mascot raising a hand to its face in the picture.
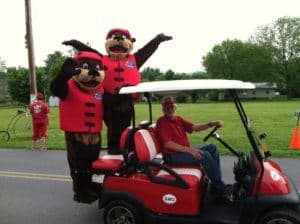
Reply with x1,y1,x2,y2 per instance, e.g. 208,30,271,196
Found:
59,79,103,133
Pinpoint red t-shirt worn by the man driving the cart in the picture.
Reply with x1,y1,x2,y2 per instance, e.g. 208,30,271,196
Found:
156,116,194,154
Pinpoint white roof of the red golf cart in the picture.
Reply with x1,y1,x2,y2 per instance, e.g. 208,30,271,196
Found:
119,79,255,94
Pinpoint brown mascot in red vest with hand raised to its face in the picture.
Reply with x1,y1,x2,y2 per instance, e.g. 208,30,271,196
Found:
50,51,104,203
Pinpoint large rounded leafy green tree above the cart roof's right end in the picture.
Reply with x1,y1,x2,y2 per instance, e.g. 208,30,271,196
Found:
203,40,276,82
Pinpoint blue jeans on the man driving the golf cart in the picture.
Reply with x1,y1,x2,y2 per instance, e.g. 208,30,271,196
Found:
169,144,225,190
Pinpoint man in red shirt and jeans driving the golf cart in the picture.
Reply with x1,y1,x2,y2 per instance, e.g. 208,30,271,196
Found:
156,96,231,200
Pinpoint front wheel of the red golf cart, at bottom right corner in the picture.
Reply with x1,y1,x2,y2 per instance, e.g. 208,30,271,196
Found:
257,208,300,224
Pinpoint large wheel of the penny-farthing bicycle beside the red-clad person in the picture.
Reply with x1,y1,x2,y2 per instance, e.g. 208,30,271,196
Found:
12,113,32,139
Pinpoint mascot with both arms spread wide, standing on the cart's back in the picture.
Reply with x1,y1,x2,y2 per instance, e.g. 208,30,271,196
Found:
63,28,172,154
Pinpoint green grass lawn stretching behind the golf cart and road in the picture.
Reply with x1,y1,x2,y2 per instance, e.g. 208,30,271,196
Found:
0,101,300,157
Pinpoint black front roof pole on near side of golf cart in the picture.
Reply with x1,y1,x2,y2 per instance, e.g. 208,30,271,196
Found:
230,90,265,197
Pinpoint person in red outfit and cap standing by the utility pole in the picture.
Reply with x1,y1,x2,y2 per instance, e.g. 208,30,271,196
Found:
30,93,50,150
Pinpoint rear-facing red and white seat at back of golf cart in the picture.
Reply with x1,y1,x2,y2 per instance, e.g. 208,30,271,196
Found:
92,126,132,173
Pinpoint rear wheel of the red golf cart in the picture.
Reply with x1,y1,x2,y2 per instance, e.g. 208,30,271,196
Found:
103,200,142,224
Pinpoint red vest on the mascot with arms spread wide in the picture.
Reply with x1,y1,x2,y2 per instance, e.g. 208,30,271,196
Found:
102,55,141,94
